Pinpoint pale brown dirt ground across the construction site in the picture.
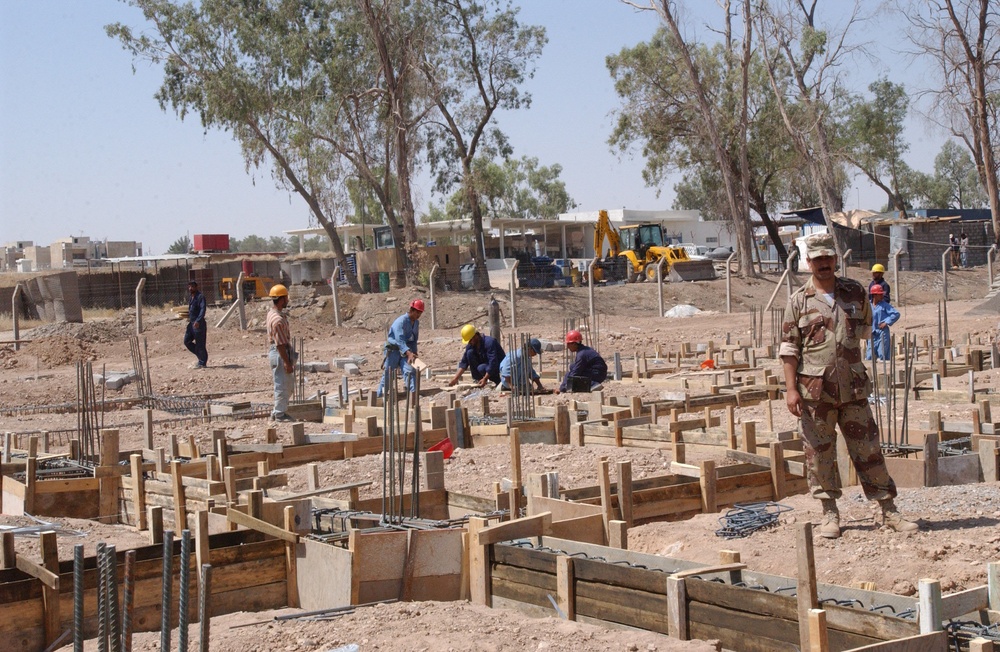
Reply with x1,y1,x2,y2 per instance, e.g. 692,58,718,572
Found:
0,268,1000,652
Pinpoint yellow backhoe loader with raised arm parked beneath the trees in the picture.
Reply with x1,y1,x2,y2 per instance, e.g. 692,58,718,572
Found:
594,211,715,283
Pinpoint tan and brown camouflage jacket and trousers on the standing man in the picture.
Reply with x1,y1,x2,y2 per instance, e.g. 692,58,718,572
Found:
778,277,896,501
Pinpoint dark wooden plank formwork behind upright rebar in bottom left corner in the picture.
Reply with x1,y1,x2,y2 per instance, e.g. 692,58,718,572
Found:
0,530,289,652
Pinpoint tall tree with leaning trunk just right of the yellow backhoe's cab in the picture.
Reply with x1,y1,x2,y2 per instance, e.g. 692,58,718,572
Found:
608,0,754,275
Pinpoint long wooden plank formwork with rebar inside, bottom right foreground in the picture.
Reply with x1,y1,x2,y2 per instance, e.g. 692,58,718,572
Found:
469,514,976,652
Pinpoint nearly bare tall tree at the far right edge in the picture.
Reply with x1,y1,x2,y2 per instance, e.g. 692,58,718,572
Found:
903,0,1000,243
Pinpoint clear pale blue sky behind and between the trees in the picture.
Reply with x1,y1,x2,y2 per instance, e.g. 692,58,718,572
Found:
0,0,943,253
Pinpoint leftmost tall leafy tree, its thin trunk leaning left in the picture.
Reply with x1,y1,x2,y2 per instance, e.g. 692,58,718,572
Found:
106,0,372,292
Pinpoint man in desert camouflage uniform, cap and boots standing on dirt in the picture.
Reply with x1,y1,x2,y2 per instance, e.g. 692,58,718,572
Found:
778,233,917,539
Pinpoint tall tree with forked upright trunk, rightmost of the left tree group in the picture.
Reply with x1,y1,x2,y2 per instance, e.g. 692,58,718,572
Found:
421,0,546,289
